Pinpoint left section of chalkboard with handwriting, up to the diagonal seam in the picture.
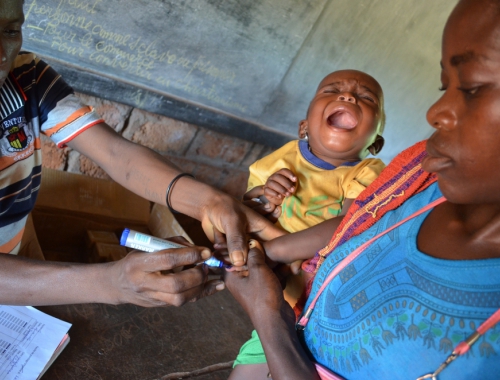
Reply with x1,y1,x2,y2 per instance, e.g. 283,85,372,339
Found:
23,0,326,148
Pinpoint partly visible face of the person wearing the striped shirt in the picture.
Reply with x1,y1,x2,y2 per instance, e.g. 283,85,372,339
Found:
0,0,24,87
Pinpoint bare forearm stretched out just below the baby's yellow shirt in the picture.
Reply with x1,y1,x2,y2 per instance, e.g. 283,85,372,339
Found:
264,216,344,263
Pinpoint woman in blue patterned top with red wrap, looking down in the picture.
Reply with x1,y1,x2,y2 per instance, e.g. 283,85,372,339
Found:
226,0,500,380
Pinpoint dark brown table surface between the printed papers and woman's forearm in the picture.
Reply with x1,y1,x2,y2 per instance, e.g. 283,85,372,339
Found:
39,290,252,380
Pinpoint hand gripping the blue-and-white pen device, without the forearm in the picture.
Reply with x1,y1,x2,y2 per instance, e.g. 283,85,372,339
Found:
108,246,224,307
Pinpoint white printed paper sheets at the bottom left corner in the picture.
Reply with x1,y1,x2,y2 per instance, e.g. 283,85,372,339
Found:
0,305,71,380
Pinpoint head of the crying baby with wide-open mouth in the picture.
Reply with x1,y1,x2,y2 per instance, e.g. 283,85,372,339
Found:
299,70,383,162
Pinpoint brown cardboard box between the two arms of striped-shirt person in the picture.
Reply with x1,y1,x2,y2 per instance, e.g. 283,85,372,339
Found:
32,168,191,262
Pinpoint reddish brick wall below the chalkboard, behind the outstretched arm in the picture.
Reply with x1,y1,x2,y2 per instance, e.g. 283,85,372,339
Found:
42,94,273,198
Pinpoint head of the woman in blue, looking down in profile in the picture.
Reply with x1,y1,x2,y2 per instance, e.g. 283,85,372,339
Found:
423,0,500,204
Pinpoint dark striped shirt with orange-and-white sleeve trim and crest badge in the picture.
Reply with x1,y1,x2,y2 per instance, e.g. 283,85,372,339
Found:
0,52,102,254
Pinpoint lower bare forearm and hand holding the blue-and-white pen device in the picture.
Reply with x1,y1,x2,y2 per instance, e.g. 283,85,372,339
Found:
0,247,224,307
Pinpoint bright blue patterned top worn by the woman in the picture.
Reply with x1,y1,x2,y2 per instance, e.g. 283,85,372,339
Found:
304,183,500,380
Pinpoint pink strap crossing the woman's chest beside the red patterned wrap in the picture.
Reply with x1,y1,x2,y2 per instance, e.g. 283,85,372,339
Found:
298,197,446,327
